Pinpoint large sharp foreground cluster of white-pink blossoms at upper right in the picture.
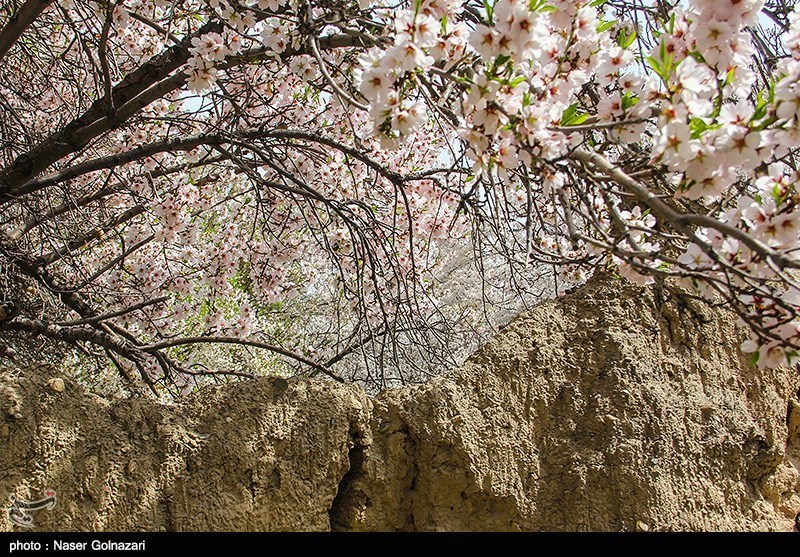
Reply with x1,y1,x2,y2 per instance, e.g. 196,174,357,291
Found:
358,0,800,365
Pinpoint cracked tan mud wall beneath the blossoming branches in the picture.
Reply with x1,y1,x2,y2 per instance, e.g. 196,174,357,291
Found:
0,278,800,530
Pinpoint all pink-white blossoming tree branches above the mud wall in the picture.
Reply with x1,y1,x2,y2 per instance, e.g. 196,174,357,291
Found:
0,0,800,394
